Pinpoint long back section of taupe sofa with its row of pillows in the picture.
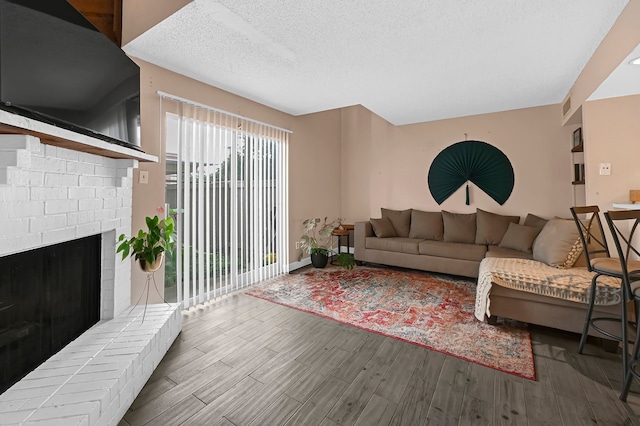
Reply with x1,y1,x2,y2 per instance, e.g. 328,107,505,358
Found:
354,208,543,277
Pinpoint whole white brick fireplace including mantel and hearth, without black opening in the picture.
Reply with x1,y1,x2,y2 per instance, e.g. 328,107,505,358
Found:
0,116,181,425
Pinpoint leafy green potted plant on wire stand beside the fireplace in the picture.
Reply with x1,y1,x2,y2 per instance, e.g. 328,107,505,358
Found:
116,216,174,272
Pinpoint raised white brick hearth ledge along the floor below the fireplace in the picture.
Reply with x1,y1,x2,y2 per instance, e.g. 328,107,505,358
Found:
0,304,182,426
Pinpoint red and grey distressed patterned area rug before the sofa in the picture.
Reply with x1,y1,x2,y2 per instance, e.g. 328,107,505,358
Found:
247,267,535,380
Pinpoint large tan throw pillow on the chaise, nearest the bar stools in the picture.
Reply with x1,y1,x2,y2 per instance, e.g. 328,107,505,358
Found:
533,218,582,268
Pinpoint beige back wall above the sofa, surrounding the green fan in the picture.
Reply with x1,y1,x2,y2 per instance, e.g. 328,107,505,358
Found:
343,105,572,220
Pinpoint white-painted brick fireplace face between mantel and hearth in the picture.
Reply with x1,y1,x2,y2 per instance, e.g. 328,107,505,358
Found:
0,135,138,319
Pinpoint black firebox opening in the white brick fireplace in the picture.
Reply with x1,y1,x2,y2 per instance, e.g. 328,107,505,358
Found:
0,235,102,393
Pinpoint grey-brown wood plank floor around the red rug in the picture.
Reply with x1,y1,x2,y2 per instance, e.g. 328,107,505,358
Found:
120,282,640,426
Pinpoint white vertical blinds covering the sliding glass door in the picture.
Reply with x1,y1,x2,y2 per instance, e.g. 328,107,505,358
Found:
159,93,290,308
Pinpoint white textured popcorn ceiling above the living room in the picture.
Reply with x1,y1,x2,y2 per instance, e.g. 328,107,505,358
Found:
124,0,628,125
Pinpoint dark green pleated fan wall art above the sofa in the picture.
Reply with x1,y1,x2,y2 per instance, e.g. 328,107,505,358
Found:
427,141,515,205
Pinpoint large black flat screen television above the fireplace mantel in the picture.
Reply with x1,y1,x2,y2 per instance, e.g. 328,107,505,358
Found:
0,0,140,150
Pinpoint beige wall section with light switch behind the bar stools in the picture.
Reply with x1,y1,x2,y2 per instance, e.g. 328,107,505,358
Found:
582,95,640,211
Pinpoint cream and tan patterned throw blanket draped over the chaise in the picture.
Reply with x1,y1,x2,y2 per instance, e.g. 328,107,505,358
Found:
475,257,620,321
